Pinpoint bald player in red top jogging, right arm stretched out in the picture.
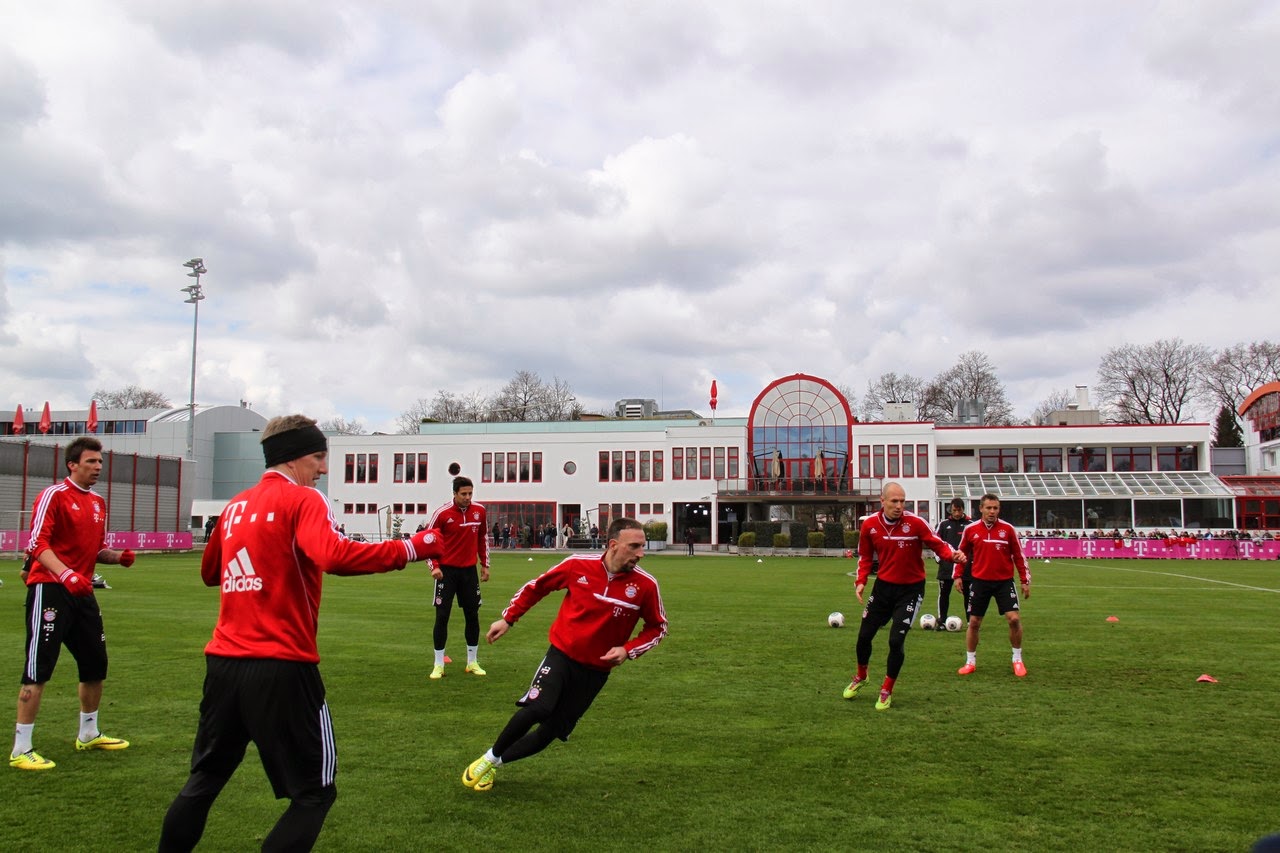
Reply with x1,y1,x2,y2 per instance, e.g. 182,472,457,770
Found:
844,483,965,711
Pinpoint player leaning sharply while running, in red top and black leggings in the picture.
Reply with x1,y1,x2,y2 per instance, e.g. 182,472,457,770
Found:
462,519,667,792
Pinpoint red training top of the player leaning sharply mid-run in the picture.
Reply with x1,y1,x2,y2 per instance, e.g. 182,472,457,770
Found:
502,555,667,670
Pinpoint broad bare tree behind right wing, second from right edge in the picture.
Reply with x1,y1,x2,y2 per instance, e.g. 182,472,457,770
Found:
1097,338,1212,424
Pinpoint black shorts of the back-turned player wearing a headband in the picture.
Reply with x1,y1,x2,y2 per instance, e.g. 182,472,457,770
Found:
183,654,338,799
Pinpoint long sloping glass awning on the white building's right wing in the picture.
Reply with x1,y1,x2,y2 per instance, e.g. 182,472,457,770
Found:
934,471,1236,501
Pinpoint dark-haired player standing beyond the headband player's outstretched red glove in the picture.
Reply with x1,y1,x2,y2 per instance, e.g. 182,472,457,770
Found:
430,476,489,679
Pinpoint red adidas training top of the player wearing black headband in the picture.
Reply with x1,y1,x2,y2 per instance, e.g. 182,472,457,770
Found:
200,471,415,663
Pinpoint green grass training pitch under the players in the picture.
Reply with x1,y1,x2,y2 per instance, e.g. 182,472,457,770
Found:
0,553,1280,852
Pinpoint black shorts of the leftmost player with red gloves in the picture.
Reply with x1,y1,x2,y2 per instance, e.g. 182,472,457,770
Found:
22,583,106,684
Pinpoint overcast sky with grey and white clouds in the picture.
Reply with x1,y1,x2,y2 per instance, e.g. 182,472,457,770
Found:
0,0,1280,429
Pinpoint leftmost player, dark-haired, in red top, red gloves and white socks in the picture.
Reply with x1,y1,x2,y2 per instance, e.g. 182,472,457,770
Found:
9,435,134,770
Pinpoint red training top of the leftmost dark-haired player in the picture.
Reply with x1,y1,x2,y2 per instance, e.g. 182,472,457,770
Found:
27,476,106,587
